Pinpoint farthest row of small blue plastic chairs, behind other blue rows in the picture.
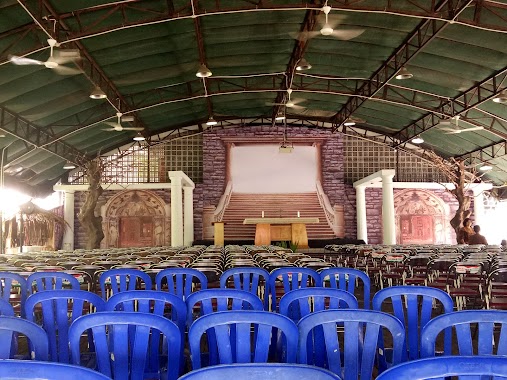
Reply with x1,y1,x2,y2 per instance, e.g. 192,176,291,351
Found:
0,267,370,310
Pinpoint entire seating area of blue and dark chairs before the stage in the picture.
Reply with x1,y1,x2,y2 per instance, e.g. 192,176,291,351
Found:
0,245,507,380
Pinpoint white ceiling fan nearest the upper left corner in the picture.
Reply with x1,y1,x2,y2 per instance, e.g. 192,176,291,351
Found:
9,38,82,75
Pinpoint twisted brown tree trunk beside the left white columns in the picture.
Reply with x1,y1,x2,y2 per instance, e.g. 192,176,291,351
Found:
78,159,104,249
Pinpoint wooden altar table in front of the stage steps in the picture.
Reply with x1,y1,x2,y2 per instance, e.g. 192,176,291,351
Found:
243,218,319,248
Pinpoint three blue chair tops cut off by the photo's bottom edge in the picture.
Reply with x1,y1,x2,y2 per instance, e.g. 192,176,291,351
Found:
0,356,507,380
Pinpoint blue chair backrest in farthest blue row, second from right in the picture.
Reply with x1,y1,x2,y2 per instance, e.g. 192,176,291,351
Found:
269,267,320,311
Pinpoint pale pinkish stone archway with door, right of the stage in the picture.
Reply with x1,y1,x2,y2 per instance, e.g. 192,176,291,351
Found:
394,189,447,244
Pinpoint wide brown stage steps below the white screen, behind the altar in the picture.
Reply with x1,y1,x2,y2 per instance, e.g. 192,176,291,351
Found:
222,192,335,240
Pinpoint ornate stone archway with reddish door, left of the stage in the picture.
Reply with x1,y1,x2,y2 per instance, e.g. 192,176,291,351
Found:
103,190,170,248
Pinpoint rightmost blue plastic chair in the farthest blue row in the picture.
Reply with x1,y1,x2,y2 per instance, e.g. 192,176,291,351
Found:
319,268,371,310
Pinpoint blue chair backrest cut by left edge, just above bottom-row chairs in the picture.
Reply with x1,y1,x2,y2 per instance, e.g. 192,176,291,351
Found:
0,316,48,361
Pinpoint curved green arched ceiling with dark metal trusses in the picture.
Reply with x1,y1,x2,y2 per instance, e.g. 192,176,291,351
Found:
0,0,507,194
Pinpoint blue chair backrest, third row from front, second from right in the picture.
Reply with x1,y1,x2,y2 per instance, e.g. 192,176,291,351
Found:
279,288,358,323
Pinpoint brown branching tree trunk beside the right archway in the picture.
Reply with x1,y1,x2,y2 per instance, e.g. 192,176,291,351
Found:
426,152,480,239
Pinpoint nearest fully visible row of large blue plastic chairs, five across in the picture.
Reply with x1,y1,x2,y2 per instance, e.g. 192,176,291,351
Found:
0,304,507,380
